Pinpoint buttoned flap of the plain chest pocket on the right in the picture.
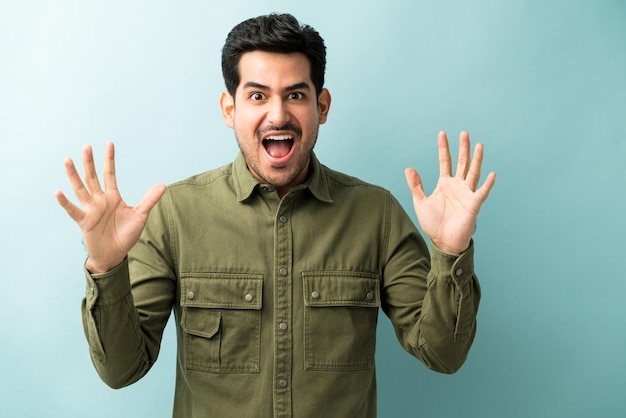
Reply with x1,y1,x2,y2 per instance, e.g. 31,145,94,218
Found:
302,272,380,308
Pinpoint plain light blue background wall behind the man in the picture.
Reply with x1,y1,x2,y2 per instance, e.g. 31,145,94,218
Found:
0,0,626,418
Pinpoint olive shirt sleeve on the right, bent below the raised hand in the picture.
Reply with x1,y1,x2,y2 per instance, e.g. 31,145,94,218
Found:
382,194,480,373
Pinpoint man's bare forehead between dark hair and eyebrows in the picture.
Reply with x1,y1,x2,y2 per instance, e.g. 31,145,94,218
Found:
239,51,313,89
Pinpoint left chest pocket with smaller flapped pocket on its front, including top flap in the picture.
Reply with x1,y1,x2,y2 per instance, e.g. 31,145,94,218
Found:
180,273,263,373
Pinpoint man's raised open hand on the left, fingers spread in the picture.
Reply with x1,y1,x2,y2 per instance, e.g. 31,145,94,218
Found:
55,142,166,274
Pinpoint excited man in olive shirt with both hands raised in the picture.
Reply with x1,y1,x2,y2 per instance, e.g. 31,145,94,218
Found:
57,15,495,418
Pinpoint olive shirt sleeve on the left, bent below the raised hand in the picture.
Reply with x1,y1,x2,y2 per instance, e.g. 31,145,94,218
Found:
82,196,176,388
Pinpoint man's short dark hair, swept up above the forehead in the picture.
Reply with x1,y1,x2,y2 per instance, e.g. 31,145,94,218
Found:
222,14,326,97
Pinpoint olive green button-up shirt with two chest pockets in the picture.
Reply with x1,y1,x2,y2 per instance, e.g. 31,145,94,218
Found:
83,155,480,418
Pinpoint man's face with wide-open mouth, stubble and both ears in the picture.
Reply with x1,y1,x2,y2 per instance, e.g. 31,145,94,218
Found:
220,51,330,196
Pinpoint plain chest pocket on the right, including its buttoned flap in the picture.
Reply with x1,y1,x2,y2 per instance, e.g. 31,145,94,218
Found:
302,272,380,371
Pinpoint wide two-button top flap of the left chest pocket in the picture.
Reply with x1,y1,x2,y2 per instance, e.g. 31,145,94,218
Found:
180,273,263,310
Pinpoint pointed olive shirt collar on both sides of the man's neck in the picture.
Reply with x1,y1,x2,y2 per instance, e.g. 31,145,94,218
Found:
233,152,333,203
